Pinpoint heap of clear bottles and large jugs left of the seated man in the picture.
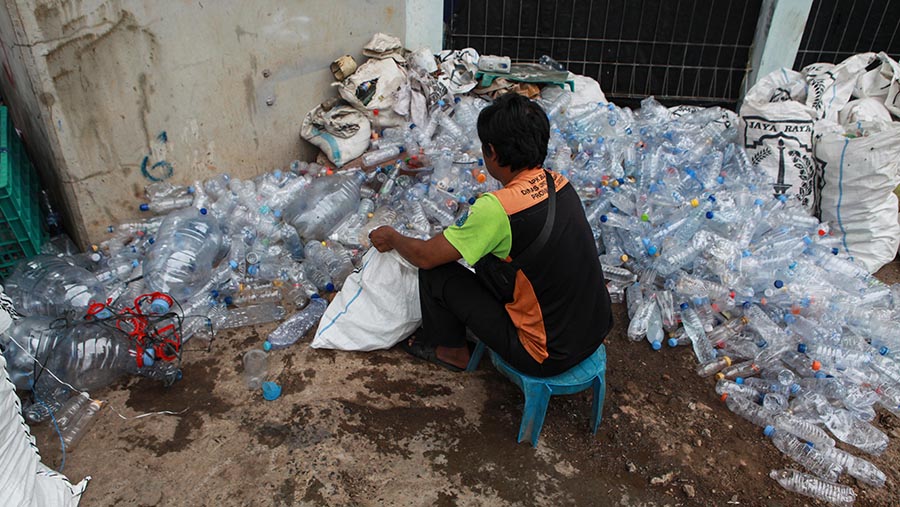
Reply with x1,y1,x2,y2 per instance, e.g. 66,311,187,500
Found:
0,97,497,422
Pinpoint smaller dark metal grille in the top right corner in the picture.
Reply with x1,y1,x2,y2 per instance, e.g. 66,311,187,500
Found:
794,0,900,69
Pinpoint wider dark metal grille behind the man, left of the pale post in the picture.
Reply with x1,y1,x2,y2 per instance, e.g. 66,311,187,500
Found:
445,0,762,105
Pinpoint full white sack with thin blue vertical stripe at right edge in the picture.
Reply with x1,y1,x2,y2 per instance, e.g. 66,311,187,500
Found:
816,122,900,273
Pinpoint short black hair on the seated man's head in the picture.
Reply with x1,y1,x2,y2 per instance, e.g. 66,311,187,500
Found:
478,93,550,171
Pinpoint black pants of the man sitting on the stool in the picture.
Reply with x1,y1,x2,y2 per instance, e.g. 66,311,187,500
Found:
416,262,565,377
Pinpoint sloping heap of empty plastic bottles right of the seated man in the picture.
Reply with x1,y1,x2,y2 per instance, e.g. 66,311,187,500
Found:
547,95,900,504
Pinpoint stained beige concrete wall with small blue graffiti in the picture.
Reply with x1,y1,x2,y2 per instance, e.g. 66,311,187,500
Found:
0,0,441,245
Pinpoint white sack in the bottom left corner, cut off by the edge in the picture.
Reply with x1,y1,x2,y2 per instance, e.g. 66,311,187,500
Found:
0,354,91,507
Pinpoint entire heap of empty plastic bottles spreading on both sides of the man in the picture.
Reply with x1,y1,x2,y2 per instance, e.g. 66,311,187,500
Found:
0,78,900,503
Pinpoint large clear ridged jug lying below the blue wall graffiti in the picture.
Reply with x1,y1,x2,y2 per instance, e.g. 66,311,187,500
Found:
144,208,223,301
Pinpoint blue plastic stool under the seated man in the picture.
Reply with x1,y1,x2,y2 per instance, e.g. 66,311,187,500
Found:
466,341,606,447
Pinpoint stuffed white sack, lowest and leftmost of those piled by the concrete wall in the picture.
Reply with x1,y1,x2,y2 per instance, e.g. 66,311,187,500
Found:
300,100,372,167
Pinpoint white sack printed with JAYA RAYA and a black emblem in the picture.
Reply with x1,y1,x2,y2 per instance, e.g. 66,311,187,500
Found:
740,70,821,210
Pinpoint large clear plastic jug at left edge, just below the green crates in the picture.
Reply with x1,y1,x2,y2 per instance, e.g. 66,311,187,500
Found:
6,255,106,317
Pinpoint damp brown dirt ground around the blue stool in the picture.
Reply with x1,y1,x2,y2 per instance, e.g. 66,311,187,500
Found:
34,260,900,507
